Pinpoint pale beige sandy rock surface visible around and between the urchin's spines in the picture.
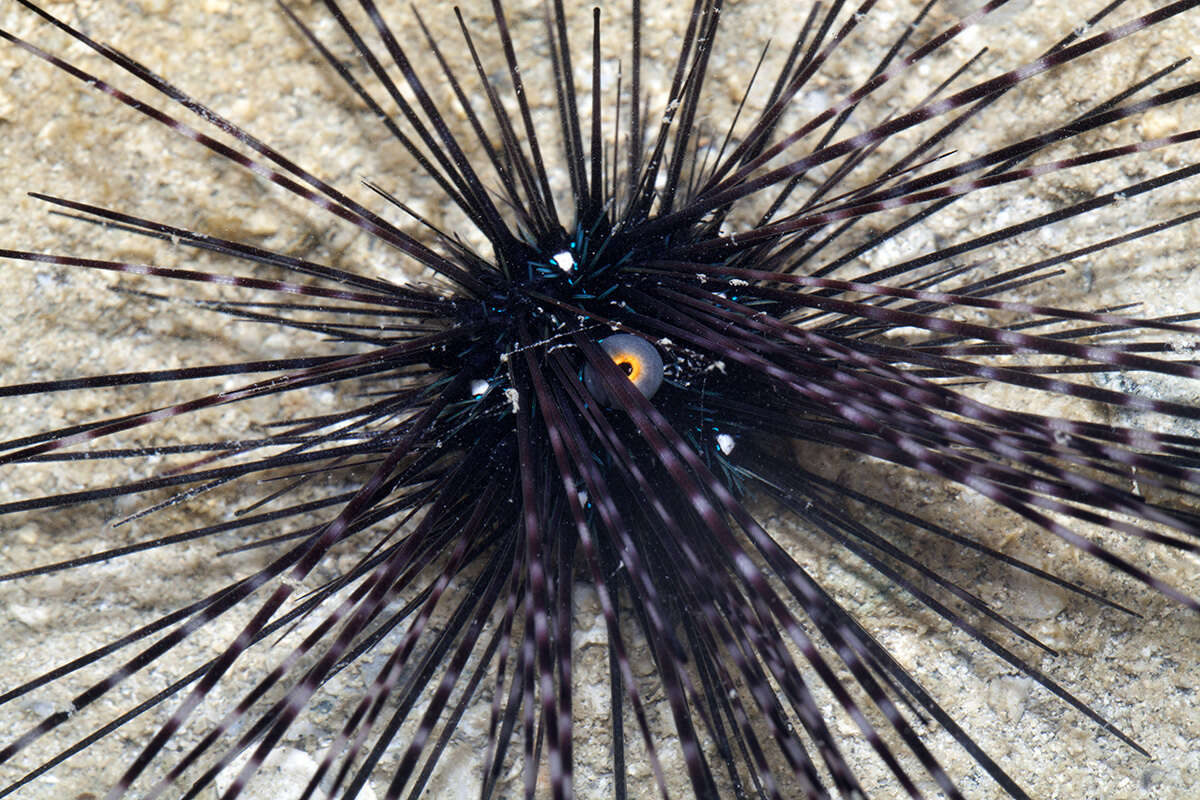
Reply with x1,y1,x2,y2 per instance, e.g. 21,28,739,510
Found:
0,0,1200,800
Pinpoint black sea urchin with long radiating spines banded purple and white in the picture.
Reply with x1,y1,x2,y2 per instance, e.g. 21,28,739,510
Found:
0,0,1200,798
